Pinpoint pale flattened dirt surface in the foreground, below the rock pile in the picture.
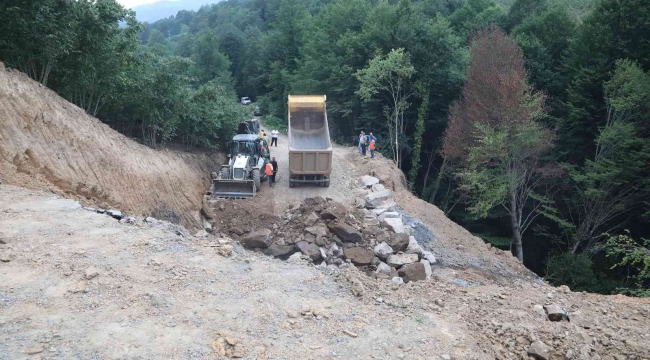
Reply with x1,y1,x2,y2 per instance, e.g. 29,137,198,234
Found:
0,185,480,360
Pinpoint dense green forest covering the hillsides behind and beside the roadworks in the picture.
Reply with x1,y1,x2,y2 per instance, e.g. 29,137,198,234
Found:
0,0,650,296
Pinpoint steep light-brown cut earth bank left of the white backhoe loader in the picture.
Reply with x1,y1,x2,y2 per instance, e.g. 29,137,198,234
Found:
0,63,221,226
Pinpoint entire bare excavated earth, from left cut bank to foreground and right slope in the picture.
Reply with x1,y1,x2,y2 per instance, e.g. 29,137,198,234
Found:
0,63,650,360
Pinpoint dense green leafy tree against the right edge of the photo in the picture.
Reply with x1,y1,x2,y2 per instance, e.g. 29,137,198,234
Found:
565,60,650,253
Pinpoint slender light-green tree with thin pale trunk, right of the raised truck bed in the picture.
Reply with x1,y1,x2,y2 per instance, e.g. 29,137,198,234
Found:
356,49,415,168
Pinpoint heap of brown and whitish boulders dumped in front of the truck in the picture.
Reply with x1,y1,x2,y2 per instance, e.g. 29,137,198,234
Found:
233,176,436,283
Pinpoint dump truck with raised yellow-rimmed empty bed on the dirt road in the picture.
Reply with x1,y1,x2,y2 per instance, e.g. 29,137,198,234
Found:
288,95,332,187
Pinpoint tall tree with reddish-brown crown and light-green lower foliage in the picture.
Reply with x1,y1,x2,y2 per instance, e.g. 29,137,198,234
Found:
443,27,552,261
